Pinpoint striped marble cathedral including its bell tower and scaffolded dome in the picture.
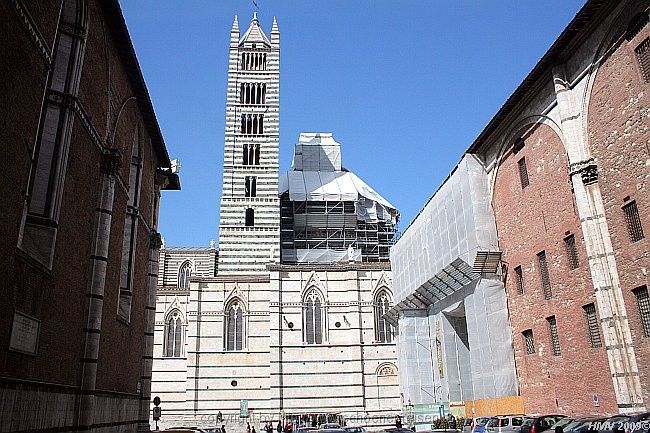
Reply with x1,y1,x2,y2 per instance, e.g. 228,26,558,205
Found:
152,16,402,426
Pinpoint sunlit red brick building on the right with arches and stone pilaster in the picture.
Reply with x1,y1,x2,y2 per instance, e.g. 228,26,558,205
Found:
391,0,650,415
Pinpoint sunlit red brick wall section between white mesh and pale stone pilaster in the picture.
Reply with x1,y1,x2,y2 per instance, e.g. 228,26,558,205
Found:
493,125,616,414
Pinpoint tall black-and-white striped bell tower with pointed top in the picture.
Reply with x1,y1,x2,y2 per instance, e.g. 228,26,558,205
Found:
218,13,280,275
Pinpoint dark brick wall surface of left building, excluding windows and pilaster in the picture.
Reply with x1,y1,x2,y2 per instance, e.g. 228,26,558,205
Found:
0,0,169,431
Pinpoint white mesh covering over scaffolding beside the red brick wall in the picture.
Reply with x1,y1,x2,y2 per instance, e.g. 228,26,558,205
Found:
390,155,517,403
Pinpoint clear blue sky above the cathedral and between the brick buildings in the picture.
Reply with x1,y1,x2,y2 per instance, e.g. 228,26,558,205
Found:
122,0,584,246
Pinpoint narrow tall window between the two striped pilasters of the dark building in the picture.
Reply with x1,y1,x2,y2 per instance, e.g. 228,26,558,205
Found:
117,125,143,321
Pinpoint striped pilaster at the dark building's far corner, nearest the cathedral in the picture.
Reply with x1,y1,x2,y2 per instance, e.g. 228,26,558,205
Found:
138,228,162,432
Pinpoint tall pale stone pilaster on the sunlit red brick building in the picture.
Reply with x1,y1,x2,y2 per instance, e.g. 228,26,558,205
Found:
553,65,645,412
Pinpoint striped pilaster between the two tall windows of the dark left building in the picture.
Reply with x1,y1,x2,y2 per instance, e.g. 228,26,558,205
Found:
77,149,122,431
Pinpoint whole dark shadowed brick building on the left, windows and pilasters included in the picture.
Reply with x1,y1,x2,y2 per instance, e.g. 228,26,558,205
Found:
0,0,180,432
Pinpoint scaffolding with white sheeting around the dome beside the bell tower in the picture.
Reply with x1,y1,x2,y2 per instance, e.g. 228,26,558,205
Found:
279,133,399,263
